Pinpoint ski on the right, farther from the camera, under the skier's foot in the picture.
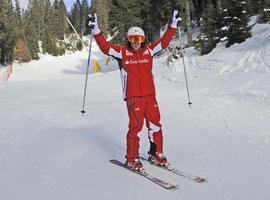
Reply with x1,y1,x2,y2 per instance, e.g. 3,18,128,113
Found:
140,156,207,183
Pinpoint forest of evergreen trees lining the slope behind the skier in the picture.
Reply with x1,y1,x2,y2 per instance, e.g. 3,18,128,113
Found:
0,0,270,65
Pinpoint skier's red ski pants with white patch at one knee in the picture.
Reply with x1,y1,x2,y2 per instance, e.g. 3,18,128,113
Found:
126,96,163,162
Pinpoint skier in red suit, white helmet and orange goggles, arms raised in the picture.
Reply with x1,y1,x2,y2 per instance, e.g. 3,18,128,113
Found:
88,11,181,170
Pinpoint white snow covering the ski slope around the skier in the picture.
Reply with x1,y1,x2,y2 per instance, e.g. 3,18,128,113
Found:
0,24,270,200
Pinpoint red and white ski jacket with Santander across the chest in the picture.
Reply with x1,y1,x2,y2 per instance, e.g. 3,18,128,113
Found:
95,27,176,100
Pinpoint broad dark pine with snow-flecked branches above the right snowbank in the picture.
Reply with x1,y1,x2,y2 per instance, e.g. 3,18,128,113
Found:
226,0,251,47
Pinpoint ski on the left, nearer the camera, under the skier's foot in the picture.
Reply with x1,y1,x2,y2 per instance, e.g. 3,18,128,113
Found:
110,159,177,190
